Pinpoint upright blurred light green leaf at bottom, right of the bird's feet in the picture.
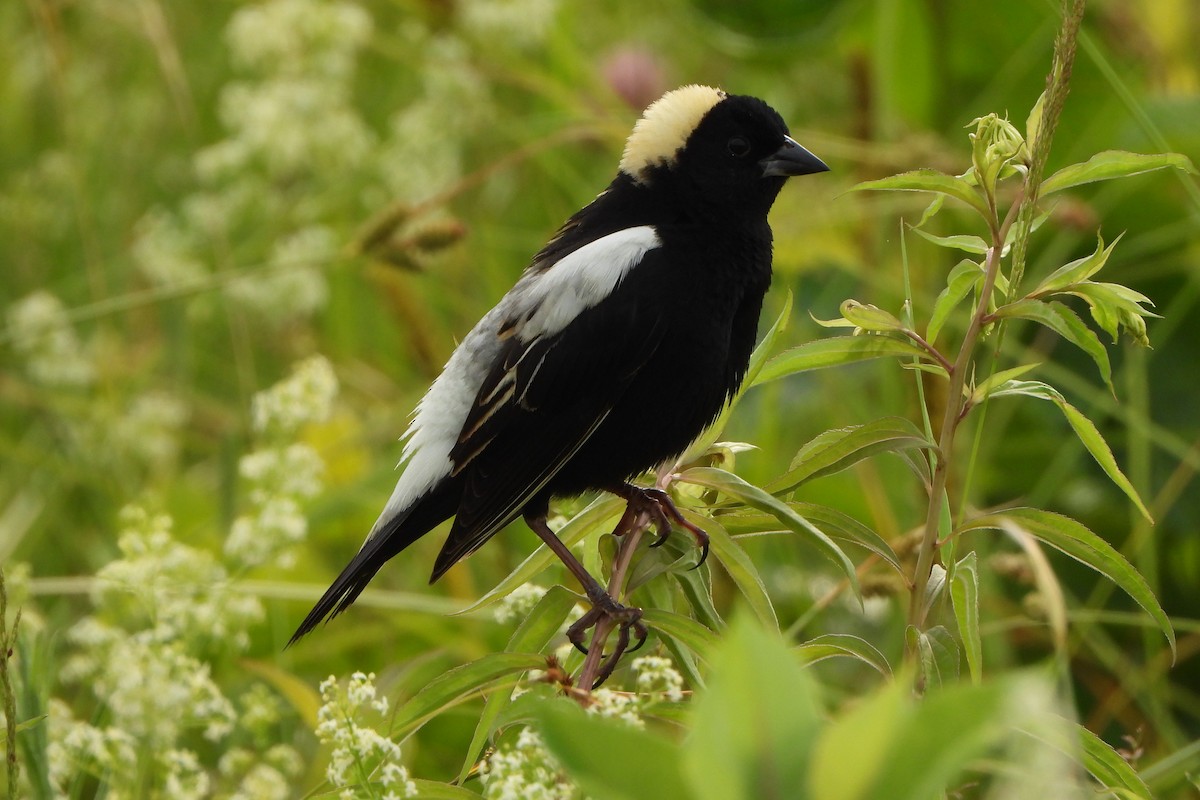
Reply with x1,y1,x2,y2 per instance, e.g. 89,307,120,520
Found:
683,614,823,800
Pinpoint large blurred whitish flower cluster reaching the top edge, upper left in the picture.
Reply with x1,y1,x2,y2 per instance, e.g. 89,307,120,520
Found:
133,0,378,323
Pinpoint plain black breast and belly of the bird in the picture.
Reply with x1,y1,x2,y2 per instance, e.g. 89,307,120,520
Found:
546,224,770,495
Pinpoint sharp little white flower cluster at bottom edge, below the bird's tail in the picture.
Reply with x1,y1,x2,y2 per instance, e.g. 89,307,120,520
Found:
317,672,416,800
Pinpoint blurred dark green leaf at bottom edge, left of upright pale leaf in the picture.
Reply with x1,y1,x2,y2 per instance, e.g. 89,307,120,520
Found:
536,699,691,800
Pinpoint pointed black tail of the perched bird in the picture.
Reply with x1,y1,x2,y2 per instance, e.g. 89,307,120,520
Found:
286,481,461,648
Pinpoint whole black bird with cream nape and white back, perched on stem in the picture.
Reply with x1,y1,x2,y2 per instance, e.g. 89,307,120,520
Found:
289,85,828,669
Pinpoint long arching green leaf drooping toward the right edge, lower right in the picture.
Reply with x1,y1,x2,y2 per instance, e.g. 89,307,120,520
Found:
961,507,1175,654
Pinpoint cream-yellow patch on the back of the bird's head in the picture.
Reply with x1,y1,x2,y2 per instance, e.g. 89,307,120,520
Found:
620,84,725,184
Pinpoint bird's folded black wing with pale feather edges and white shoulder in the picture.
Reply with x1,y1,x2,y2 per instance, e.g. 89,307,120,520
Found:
433,228,662,579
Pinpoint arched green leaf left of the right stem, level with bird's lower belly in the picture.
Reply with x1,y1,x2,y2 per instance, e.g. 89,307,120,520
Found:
766,416,932,494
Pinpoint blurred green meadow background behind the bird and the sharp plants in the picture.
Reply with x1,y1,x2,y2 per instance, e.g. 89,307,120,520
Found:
0,0,1200,786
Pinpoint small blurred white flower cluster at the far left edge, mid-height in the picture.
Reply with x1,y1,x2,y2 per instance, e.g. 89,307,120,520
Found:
8,290,96,387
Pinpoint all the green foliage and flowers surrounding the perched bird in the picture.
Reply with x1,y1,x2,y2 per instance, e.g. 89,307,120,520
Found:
0,0,1200,800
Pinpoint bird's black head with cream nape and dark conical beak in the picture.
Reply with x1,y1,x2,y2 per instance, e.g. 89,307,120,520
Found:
620,85,829,216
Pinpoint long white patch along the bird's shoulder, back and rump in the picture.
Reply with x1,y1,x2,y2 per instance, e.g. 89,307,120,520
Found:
367,225,662,541
